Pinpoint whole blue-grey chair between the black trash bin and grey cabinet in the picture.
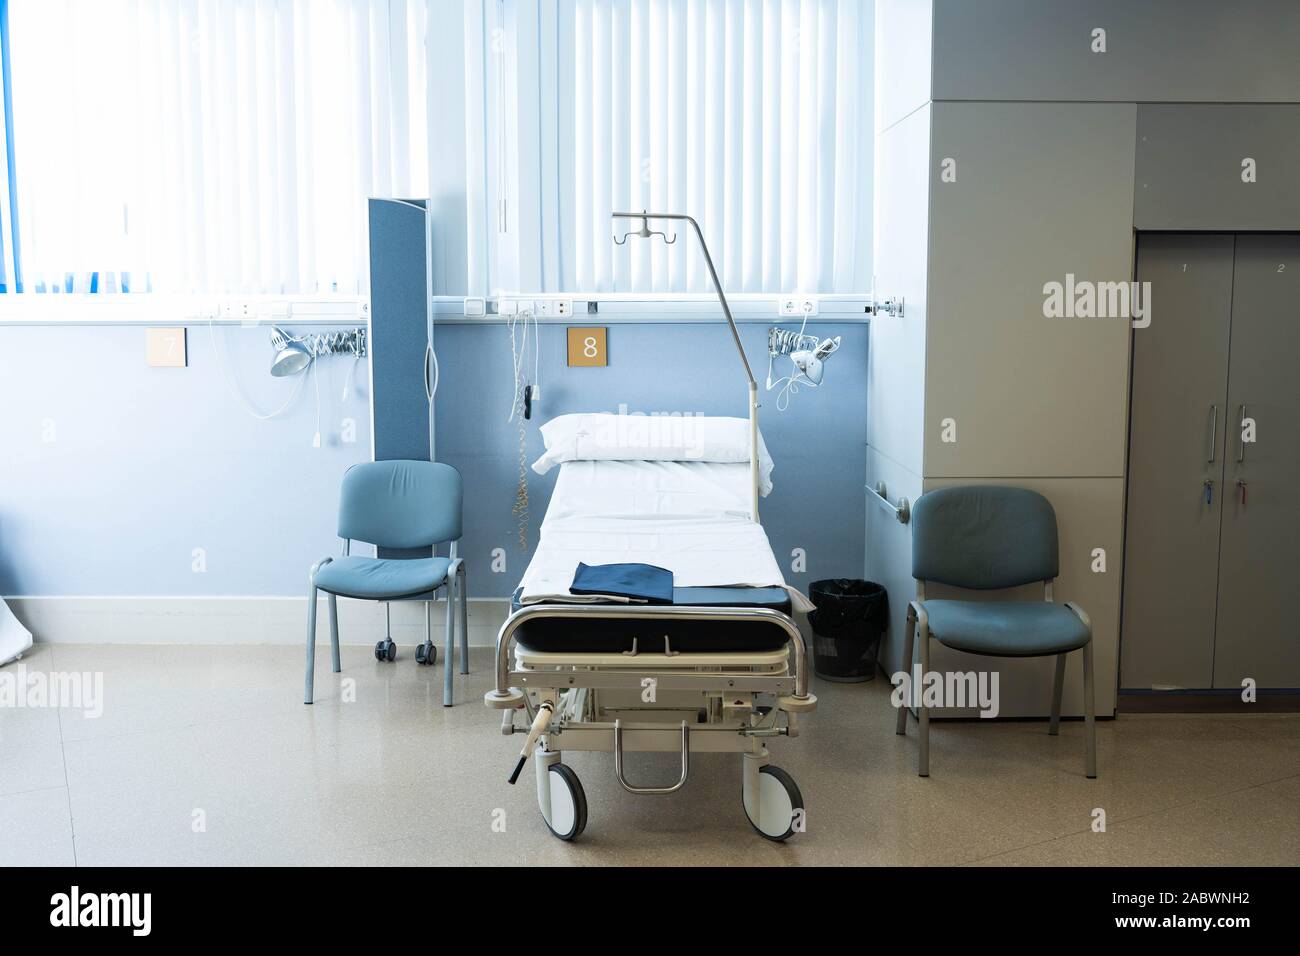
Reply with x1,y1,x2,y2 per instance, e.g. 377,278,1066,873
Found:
897,485,1097,778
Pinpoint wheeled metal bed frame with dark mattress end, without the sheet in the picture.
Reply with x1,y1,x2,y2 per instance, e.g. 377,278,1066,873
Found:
485,574,816,840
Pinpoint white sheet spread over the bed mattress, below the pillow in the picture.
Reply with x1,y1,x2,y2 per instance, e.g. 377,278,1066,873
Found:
520,462,813,611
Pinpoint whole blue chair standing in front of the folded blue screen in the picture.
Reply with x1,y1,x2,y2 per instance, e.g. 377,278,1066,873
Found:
303,460,469,708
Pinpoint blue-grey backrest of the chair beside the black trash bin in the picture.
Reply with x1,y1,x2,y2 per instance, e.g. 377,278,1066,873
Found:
911,485,1061,591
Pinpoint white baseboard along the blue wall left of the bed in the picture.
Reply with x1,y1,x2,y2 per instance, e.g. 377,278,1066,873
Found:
7,597,510,646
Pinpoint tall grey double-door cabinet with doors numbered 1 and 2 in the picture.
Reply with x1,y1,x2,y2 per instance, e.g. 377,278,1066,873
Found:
1121,234,1300,689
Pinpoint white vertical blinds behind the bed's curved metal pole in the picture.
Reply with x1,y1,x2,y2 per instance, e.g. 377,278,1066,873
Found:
465,0,874,294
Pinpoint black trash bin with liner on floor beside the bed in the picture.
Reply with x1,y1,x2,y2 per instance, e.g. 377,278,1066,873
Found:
809,578,889,683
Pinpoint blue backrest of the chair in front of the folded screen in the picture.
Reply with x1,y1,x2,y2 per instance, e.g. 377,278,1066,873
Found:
338,459,464,548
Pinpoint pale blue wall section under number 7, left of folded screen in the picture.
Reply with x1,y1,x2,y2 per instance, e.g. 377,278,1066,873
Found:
0,325,371,596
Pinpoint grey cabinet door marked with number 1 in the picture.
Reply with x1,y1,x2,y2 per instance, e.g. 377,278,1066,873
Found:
1119,234,1232,689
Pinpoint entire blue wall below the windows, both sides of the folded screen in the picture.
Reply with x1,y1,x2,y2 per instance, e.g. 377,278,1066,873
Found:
0,323,867,596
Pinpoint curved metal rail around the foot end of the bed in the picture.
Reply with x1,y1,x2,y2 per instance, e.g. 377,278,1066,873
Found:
484,604,815,708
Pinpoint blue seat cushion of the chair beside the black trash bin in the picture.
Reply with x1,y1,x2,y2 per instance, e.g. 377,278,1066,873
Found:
923,601,1092,657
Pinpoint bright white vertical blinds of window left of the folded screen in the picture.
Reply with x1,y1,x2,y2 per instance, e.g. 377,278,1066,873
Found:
9,0,428,293
